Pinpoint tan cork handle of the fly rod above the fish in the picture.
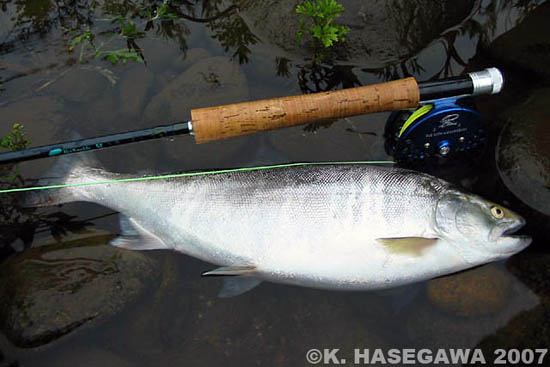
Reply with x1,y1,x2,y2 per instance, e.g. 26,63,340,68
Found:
191,78,420,143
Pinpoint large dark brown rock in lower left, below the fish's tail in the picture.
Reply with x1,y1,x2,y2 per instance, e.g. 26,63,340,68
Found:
0,234,158,348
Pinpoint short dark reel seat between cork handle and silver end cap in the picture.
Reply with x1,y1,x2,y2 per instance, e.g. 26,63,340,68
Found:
418,75,474,102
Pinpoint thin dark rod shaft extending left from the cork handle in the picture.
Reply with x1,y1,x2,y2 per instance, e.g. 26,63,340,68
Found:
0,122,189,164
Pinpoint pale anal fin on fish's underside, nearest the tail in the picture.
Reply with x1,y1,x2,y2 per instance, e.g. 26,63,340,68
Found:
111,214,170,250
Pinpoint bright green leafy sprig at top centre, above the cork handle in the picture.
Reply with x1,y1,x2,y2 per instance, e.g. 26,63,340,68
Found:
296,0,349,62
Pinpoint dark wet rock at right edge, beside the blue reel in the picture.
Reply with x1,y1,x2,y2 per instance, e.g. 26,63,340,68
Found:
496,89,550,215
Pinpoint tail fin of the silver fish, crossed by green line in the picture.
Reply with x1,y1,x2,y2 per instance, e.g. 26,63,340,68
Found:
20,153,99,207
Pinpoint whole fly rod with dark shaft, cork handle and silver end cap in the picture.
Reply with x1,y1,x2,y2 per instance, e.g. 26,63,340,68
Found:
0,68,504,164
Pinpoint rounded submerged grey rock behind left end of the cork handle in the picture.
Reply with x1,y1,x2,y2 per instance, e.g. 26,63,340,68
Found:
144,55,249,171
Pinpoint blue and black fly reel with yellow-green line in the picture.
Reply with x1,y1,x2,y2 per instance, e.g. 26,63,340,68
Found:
384,97,487,169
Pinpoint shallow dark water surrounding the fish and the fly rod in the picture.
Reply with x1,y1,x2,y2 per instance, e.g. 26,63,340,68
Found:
0,0,550,366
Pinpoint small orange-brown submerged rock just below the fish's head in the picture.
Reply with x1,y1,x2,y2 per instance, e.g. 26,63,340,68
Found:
428,265,511,317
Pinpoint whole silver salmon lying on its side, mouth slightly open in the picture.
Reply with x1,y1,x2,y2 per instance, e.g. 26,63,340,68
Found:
27,159,531,296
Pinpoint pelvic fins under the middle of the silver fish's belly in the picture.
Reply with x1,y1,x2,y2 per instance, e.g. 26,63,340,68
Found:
202,265,261,298
